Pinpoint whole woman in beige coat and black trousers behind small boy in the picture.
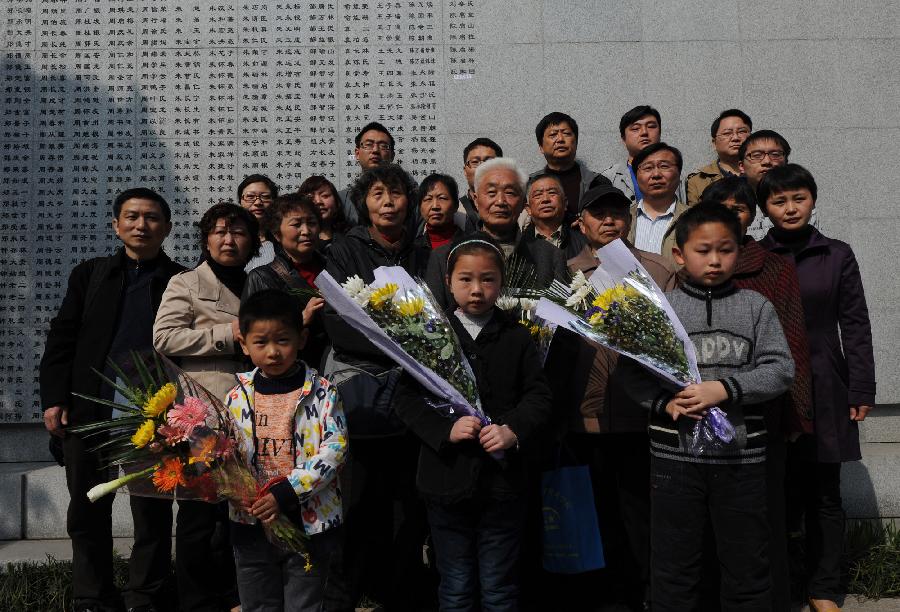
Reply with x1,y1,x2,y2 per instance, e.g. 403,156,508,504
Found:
153,203,259,612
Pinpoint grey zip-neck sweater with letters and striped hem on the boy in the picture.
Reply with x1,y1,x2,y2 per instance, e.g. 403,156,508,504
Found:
620,281,794,464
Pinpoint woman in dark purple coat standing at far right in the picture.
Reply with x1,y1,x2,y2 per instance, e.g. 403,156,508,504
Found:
757,164,875,611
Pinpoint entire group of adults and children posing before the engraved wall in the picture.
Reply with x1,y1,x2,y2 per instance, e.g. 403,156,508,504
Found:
40,106,875,612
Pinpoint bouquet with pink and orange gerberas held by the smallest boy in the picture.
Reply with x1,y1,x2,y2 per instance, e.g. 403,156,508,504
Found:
71,352,306,552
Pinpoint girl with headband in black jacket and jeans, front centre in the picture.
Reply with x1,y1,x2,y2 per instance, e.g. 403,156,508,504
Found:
397,234,552,611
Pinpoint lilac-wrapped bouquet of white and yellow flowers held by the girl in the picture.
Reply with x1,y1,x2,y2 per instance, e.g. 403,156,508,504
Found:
316,267,490,425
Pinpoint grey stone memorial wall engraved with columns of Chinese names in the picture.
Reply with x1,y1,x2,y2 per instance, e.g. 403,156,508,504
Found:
0,0,900,423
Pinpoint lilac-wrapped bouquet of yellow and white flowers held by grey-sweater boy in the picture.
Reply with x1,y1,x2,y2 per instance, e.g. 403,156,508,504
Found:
536,240,735,455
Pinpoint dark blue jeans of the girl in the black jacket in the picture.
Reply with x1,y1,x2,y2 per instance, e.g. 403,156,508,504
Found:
428,499,525,612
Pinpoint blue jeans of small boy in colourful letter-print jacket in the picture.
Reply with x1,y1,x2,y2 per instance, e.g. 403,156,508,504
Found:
231,522,341,612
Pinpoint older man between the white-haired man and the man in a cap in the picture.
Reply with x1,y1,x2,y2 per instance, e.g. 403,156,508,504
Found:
522,174,588,259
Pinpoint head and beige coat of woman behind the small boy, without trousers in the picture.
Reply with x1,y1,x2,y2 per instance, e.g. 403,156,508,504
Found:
153,203,259,400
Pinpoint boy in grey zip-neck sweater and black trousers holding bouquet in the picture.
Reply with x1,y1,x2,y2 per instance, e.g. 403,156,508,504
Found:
622,206,794,612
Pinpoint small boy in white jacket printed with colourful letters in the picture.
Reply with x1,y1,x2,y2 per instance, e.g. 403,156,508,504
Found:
225,289,347,612
